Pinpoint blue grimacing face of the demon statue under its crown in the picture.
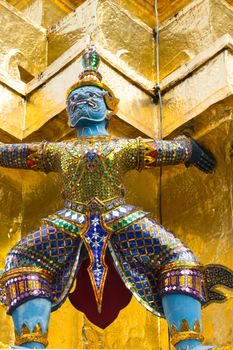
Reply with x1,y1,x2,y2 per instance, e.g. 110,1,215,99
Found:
67,86,107,128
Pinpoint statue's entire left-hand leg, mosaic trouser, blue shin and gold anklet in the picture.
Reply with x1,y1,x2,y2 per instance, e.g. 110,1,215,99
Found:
4,224,80,349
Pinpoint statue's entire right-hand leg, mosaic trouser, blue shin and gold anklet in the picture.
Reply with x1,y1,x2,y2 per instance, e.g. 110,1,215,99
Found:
110,218,207,350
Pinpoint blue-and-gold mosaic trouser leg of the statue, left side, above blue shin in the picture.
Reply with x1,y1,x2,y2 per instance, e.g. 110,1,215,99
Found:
2,224,81,314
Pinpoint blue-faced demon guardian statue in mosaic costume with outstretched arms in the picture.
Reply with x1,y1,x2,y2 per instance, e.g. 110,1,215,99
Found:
0,47,233,350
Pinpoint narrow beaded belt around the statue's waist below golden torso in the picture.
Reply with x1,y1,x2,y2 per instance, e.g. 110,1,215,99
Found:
65,197,125,214
